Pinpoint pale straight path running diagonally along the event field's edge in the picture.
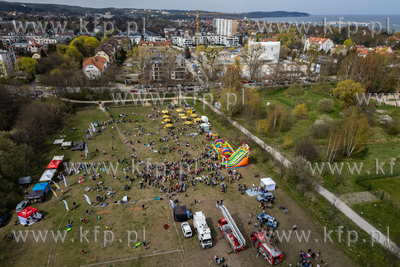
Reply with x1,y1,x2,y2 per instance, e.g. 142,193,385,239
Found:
61,98,400,257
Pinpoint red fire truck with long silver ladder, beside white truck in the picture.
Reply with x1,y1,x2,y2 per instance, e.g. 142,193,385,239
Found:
217,203,246,253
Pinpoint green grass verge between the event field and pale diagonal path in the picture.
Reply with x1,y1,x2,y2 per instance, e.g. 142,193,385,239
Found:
192,95,397,266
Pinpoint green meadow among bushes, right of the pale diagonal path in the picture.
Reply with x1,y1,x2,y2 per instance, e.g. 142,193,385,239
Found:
212,87,400,258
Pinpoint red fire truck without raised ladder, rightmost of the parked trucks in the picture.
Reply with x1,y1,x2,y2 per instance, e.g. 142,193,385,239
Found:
250,230,283,265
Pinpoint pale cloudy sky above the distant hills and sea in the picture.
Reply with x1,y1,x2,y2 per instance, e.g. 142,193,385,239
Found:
7,0,400,15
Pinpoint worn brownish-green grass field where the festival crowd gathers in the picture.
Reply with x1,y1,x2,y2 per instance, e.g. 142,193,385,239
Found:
0,103,360,266
